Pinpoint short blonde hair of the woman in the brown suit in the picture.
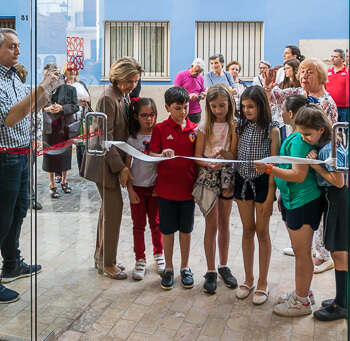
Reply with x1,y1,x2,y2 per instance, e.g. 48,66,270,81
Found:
109,57,145,84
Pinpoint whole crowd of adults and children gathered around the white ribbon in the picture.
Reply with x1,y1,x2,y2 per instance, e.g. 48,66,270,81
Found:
0,29,349,321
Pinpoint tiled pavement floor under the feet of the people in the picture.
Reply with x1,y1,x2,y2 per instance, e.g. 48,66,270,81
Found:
0,157,347,341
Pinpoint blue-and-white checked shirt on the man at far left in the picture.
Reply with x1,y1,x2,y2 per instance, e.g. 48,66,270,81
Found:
0,64,30,148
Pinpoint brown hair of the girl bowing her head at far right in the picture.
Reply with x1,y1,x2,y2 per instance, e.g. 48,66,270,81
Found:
294,104,332,143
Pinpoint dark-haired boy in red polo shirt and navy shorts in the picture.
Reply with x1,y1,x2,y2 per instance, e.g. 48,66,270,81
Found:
150,86,197,290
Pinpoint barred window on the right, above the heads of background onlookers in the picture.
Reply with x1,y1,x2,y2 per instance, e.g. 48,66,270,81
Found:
196,21,264,80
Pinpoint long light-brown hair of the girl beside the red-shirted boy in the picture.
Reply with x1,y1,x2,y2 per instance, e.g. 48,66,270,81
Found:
204,83,236,146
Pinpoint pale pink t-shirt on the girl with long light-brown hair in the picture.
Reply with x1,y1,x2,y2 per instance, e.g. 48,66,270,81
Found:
196,121,231,158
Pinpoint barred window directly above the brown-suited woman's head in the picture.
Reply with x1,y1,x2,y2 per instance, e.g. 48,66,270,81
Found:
104,21,170,81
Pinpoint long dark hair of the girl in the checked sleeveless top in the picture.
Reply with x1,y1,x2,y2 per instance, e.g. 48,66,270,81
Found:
238,85,272,138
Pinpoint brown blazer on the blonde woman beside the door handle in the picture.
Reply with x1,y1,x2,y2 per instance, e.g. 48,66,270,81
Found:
81,84,129,188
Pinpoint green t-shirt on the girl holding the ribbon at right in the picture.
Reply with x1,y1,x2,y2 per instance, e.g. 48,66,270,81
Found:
275,133,321,210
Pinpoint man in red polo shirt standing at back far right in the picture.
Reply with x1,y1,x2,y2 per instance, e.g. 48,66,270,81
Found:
325,49,349,122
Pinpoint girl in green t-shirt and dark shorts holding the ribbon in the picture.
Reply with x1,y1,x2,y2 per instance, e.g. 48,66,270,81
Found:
255,95,322,316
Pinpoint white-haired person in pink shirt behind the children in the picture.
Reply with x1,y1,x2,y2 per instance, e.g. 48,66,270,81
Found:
174,58,205,123
